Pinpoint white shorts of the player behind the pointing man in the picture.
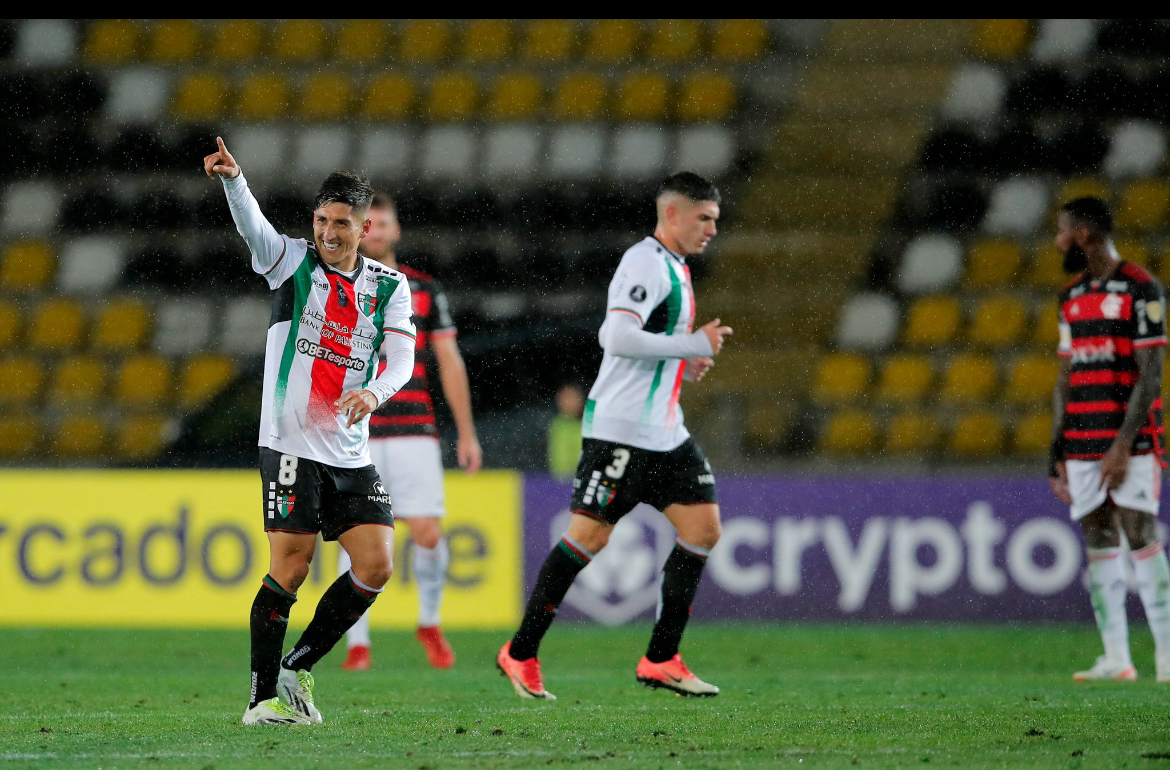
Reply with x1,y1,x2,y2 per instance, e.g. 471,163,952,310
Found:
370,435,447,518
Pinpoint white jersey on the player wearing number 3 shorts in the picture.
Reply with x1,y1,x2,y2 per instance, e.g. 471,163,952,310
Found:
581,236,695,452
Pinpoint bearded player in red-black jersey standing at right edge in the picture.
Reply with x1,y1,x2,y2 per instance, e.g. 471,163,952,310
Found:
1048,198,1170,682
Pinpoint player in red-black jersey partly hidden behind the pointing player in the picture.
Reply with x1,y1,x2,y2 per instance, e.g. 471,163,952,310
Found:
337,193,483,671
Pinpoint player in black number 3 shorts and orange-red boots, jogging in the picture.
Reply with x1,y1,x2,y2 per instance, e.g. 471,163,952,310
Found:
496,172,731,700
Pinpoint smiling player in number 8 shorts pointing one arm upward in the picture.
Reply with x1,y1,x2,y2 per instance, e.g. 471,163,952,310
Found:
204,138,415,724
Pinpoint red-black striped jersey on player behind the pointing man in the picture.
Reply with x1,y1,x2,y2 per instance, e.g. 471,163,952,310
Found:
370,264,455,439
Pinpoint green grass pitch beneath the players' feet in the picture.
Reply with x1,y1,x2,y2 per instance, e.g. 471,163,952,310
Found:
0,623,1170,770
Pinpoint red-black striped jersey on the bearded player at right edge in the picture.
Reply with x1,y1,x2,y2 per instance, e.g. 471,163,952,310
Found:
1058,261,1166,460
